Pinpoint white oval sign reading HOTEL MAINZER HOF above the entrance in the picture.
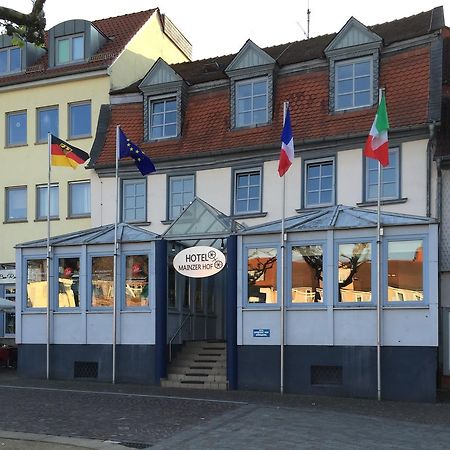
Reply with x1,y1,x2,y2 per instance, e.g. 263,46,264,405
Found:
173,246,226,278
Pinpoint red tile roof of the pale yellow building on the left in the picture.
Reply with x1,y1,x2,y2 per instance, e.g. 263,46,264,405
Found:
0,9,158,86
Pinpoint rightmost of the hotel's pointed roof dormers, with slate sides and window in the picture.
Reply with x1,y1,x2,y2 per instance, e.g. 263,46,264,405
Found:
325,17,382,112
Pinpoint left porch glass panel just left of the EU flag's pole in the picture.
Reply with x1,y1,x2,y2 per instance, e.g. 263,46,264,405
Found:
91,256,114,308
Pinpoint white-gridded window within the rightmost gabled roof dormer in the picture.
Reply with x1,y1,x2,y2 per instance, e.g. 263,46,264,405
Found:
335,59,372,110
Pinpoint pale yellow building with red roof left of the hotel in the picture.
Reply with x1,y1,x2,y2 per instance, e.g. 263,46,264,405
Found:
0,9,191,336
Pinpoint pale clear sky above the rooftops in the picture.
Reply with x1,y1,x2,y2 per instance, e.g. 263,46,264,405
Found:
0,0,450,59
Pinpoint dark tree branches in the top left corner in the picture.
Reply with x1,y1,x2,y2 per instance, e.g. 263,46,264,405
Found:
0,0,46,46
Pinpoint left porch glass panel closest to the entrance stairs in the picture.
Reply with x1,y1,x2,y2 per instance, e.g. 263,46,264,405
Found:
125,255,149,307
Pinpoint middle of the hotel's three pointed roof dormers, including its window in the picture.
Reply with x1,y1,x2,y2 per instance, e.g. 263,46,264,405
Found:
225,39,276,128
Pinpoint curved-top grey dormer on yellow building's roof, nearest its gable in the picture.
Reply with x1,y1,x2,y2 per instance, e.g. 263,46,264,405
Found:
48,19,107,67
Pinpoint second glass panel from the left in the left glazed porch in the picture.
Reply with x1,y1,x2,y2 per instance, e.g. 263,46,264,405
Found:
58,258,80,308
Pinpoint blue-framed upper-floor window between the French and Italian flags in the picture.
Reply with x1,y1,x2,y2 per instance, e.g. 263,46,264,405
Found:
305,160,334,207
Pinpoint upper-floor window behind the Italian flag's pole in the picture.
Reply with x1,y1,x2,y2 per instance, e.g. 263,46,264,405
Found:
364,148,400,201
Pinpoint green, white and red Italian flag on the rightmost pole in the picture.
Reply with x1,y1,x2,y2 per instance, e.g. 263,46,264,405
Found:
364,93,389,167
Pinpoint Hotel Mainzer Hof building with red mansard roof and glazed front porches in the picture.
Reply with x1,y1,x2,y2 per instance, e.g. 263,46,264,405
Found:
17,8,446,400
